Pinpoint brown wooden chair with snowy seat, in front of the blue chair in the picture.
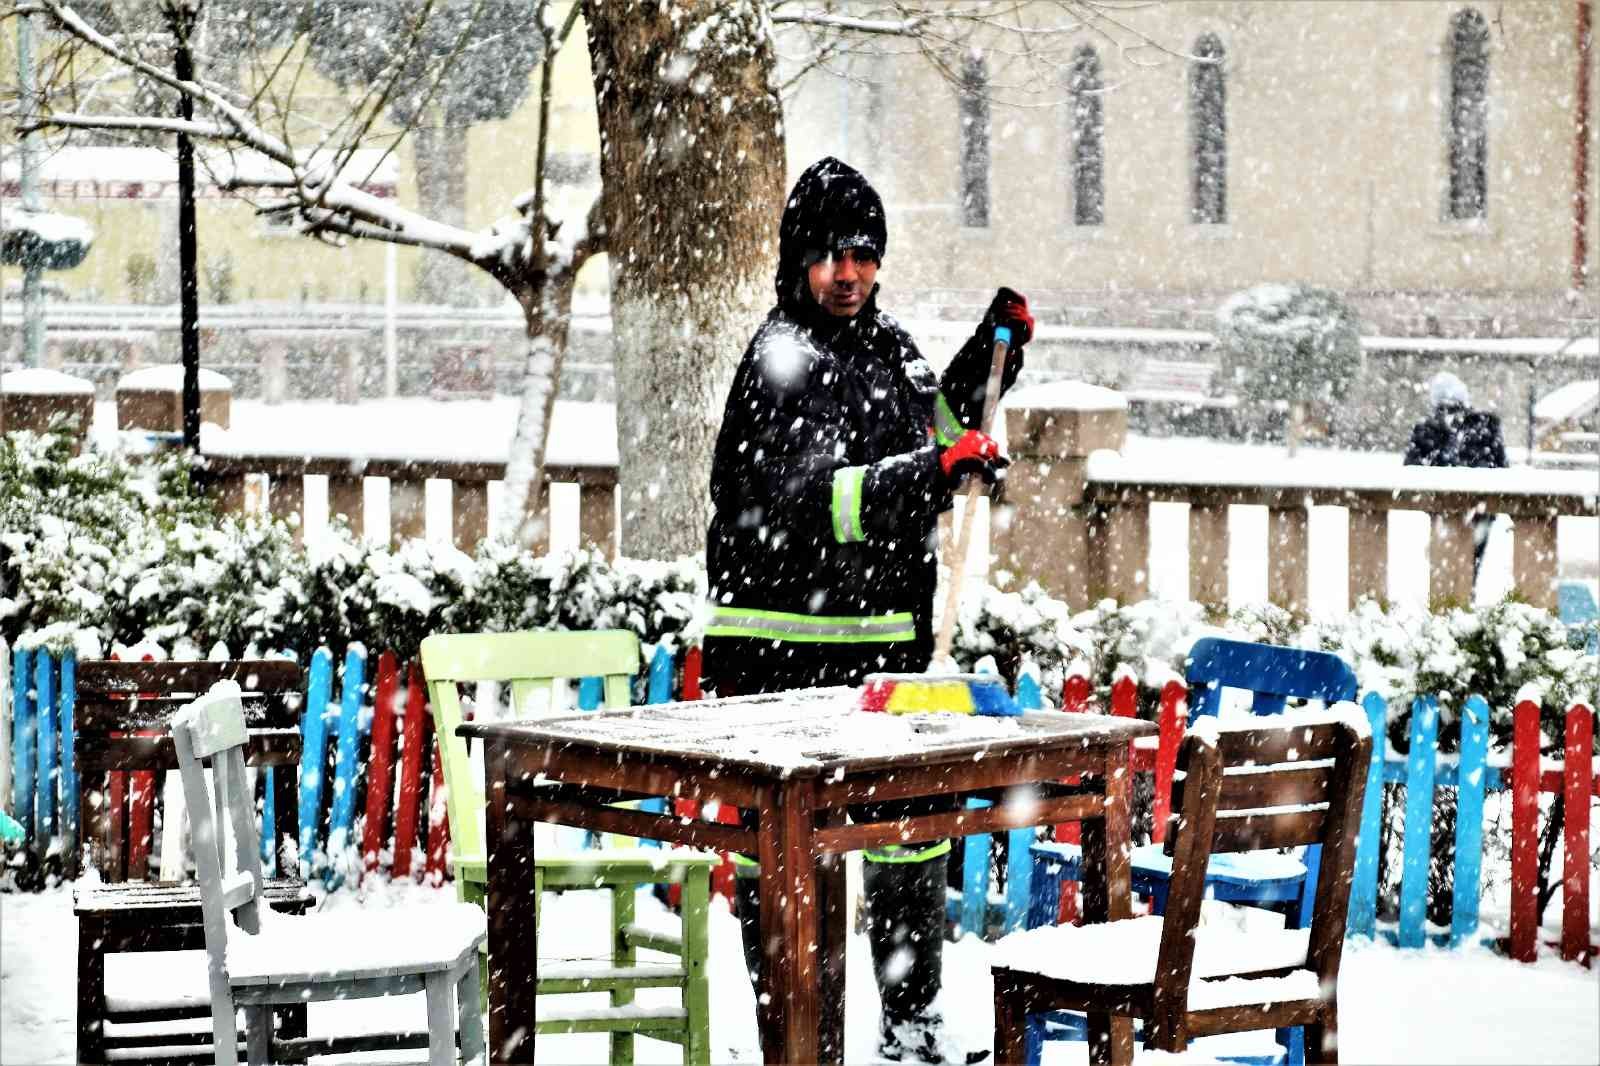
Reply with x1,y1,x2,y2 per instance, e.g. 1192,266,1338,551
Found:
992,704,1373,1063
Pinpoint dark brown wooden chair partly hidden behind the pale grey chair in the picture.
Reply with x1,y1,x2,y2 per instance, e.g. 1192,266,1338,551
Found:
70,659,310,1063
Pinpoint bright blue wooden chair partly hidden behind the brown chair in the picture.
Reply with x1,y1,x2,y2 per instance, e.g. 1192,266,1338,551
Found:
1027,637,1357,1066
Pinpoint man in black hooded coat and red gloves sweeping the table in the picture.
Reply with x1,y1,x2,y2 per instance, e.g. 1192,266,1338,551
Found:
704,158,1034,1061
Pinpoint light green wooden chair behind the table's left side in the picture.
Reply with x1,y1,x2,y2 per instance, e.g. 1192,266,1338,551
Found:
422,631,717,1063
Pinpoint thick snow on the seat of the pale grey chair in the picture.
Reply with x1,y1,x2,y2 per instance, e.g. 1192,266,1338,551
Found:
227,903,488,984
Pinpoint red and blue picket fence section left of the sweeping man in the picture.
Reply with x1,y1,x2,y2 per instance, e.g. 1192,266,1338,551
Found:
0,645,734,895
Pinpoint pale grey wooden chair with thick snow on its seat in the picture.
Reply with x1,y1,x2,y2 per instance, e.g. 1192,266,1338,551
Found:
171,682,488,1066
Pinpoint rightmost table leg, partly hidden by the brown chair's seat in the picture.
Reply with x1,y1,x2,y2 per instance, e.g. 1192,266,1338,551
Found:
1083,744,1133,1063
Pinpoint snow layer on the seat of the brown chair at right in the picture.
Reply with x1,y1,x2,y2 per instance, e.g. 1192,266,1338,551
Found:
992,914,1310,984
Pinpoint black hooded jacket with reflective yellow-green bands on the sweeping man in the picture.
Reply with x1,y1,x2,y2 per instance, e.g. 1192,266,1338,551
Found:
704,158,1021,695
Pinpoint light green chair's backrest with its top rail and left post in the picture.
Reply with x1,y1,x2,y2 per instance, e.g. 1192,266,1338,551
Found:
422,629,640,858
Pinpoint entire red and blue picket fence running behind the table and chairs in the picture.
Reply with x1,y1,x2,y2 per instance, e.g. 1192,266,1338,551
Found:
0,645,1600,960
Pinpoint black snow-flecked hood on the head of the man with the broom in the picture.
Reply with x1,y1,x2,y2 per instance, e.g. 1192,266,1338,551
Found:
776,155,890,311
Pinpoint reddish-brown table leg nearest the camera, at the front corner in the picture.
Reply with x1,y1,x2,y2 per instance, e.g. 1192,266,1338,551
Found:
757,778,822,1063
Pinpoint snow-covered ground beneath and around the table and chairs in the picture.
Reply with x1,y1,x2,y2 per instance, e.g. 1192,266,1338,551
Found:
0,884,1600,1066
